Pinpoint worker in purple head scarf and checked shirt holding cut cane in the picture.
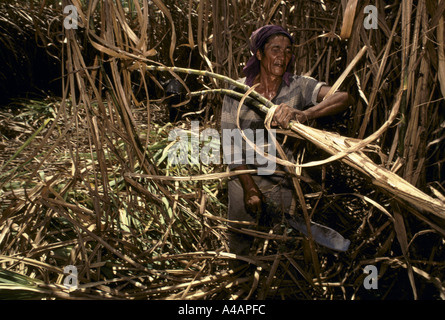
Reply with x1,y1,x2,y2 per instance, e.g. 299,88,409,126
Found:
221,25,351,264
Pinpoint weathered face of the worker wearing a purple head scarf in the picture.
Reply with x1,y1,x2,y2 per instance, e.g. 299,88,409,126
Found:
257,35,292,77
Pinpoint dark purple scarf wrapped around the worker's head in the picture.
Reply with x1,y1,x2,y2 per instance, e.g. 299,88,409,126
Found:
243,25,295,86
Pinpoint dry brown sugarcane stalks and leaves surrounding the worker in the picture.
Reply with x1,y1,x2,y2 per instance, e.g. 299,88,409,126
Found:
0,0,445,299
